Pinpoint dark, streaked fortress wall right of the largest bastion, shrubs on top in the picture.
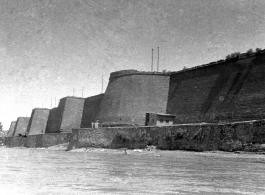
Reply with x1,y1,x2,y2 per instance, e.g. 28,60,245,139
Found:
167,54,265,123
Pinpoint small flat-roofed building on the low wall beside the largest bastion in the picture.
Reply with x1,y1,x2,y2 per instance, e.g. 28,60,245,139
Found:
145,113,176,126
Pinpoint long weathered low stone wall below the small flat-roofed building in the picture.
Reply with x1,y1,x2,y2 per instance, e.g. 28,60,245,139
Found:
68,120,265,151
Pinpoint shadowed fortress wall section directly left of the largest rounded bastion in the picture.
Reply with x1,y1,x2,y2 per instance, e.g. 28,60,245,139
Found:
81,94,104,128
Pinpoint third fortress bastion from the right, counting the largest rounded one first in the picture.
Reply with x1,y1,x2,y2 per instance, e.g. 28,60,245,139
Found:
27,108,50,135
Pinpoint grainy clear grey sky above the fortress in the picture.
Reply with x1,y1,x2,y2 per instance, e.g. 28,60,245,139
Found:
0,0,265,130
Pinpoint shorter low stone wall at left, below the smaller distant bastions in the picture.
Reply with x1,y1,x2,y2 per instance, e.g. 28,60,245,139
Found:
5,133,71,148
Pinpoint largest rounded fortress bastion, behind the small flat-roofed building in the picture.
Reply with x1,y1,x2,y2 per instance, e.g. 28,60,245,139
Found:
96,71,169,125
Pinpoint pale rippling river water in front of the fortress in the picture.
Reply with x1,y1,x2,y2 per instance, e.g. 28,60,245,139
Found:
0,147,265,195
